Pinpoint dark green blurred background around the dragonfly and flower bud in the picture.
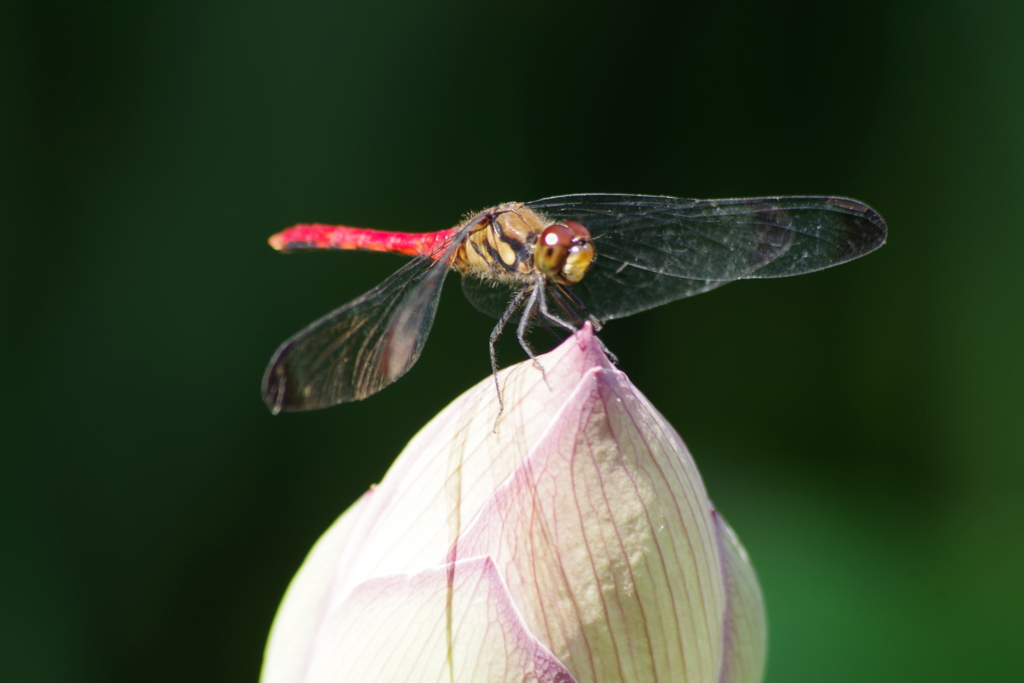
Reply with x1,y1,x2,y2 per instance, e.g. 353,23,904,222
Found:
0,0,1024,683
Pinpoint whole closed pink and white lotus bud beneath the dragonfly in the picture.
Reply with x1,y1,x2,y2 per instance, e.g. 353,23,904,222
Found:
263,329,765,683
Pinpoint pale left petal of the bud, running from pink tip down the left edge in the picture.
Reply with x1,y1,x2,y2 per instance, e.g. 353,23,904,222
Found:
262,327,608,683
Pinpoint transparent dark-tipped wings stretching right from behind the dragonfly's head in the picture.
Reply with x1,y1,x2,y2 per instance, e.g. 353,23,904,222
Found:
528,195,886,319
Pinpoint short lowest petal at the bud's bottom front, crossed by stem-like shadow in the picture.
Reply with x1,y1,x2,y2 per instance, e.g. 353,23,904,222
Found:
303,558,573,683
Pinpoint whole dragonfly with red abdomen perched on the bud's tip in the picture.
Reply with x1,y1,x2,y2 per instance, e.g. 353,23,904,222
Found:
263,195,887,414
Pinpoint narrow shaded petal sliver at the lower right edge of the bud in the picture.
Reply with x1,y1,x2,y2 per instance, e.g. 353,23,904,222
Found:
715,511,768,683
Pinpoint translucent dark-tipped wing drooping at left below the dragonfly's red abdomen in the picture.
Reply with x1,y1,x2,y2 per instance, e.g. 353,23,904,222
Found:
263,250,447,414
